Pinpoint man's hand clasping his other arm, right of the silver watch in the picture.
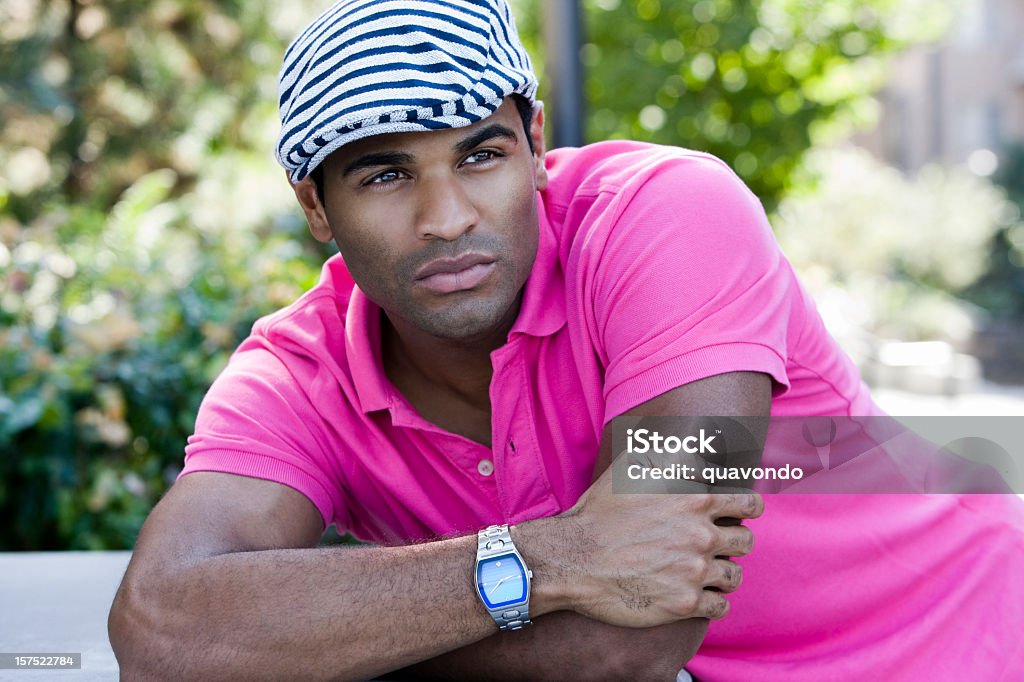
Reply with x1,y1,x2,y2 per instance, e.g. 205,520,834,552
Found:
562,469,764,628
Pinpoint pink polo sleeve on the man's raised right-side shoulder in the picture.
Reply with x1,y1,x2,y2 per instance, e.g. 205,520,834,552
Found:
589,153,799,422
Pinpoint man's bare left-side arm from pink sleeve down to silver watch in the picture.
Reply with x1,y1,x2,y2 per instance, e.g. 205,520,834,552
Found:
110,473,516,680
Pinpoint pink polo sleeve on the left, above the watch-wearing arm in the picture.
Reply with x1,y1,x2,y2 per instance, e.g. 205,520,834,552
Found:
181,337,347,527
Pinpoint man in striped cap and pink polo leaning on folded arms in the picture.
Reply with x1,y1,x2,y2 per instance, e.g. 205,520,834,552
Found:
111,0,1024,680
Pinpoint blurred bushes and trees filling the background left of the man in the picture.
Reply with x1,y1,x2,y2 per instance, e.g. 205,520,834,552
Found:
0,0,326,550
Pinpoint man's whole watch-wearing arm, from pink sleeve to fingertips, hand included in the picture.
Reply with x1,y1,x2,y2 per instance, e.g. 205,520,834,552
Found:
110,372,762,680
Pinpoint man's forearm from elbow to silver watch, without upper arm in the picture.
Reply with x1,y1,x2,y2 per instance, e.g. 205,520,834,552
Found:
111,518,560,680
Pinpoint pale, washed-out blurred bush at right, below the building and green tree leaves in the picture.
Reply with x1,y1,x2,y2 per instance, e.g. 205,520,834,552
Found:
774,147,1024,346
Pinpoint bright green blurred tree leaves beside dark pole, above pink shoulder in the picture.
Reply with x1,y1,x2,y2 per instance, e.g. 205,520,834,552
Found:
519,0,958,211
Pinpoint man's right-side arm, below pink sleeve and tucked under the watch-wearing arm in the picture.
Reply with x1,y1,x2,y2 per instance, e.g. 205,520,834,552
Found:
396,373,771,682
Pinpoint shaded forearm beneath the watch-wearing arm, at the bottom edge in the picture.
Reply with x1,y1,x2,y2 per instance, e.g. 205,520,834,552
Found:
385,611,708,682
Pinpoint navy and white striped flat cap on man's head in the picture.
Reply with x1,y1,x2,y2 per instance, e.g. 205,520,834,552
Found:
276,0,537,182
